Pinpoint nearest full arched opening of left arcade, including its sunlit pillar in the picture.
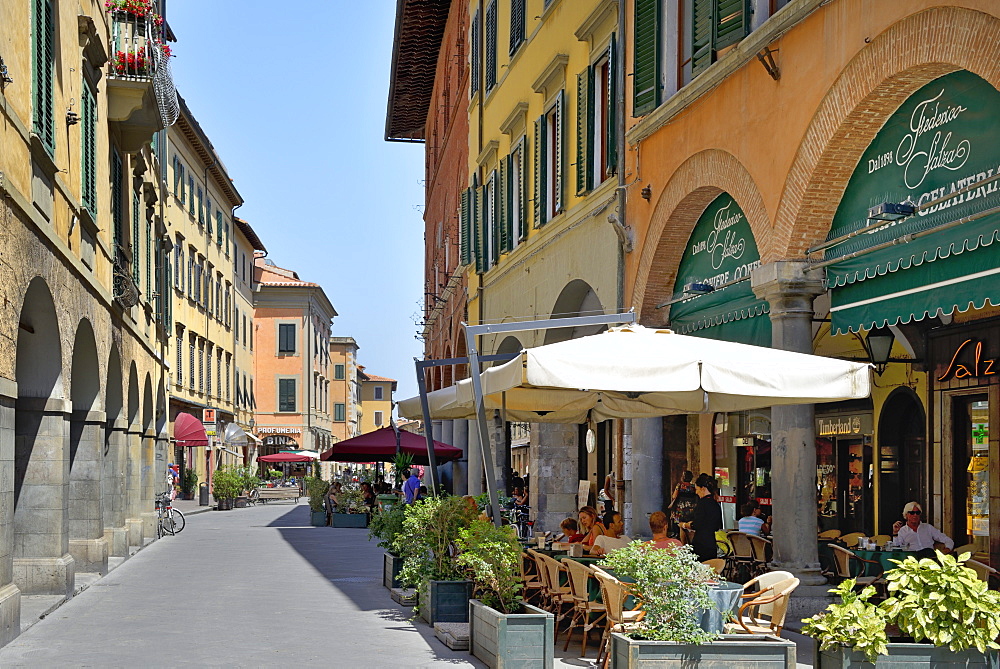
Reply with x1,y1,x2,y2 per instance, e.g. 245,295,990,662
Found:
12,277,73,595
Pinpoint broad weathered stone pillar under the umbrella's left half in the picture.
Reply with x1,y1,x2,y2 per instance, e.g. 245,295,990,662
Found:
529,423,580,532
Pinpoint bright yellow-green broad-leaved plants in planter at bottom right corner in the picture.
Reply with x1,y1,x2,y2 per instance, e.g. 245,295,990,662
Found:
802,552,1000,668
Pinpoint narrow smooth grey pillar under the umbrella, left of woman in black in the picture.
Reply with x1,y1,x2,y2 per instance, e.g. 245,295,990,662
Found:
629,418,667,537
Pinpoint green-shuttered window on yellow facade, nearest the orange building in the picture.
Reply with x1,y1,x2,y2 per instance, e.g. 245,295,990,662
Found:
576,44,617,195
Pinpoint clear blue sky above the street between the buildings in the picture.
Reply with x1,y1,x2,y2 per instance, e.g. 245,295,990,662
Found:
167,0,424,399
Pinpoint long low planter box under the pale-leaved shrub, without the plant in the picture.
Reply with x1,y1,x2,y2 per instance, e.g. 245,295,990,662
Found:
611,633,795,669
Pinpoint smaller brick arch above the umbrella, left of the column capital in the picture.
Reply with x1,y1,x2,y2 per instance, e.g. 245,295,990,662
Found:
632,149,771,325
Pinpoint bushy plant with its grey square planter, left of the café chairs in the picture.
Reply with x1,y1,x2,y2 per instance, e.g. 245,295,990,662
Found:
456,519,555,667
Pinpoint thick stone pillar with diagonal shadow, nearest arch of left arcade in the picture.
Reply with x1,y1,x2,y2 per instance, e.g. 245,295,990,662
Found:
13,397,75,597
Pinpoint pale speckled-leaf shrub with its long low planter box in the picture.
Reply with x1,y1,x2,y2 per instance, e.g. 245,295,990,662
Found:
602,542,795,668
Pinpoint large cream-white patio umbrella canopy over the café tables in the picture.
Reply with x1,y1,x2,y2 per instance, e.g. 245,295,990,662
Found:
399,325,870,423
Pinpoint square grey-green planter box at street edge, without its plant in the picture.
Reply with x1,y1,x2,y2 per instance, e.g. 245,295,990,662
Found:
469,599,555,669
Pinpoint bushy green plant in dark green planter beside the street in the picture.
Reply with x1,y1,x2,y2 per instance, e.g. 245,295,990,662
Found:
393,497,477,625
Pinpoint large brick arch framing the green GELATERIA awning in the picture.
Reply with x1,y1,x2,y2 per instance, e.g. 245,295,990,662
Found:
772,7,1000,260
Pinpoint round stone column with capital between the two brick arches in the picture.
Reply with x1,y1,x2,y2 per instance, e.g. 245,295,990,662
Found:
750,261,827,604
